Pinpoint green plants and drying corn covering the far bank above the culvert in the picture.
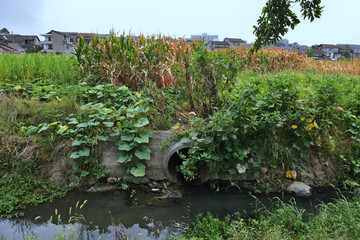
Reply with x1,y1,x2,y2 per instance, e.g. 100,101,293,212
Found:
0,32,360,222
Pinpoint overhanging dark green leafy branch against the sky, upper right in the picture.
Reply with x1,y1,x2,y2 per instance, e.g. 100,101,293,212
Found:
250,0,323,53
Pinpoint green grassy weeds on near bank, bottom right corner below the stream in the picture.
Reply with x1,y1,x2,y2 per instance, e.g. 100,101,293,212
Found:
178,194,360,240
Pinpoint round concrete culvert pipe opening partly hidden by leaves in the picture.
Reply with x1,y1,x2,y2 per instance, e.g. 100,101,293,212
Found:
164,142,209,185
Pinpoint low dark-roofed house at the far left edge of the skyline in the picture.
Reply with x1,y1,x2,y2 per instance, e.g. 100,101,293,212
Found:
0,34,40,52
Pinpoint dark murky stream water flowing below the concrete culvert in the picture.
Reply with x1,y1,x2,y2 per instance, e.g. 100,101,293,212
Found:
0,187,342,240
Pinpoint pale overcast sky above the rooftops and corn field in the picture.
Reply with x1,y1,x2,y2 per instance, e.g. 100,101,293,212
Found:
0,0,360,45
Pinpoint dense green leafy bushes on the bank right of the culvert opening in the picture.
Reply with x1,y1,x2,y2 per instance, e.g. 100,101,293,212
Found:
181,73,360,182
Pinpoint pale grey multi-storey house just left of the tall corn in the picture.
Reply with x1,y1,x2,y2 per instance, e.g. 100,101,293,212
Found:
41,30,78,54
